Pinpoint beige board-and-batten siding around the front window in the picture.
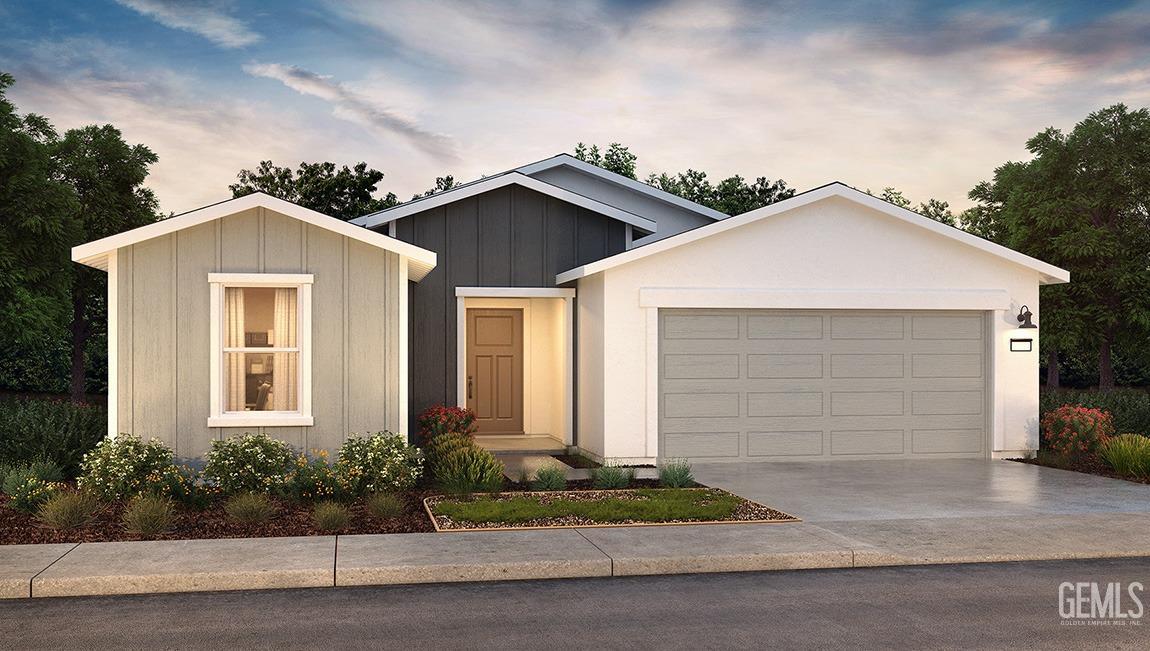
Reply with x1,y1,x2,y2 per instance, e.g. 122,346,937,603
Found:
115,208,406,457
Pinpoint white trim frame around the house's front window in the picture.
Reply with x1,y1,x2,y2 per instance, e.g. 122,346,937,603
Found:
208,274,314,427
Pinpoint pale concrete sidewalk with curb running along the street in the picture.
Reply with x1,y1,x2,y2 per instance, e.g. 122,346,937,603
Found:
0,513,1150,598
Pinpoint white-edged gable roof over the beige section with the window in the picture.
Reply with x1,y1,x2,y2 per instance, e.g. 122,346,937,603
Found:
72,192,436,281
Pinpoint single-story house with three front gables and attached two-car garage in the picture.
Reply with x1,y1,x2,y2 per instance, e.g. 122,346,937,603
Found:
72,155,1070,462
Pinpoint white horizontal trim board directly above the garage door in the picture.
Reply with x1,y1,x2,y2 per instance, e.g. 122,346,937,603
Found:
639,288,1011,311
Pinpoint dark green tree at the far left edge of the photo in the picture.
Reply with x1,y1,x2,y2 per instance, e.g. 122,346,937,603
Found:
0,72,78,391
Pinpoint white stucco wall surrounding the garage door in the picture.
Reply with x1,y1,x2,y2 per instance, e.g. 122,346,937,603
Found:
578,197,1040,460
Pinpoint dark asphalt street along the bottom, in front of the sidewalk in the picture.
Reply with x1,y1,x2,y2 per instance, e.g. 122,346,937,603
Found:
0,559,1150,650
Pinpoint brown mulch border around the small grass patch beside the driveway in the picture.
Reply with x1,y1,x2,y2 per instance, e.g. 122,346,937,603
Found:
426,487,799,531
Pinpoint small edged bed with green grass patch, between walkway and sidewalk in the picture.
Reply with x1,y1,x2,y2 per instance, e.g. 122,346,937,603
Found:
426,488,797,531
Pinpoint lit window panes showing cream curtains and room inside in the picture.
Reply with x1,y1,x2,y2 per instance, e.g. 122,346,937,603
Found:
223,288,299,412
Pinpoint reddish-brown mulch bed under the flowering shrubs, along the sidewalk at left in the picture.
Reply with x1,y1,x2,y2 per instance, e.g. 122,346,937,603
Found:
0,491,435,545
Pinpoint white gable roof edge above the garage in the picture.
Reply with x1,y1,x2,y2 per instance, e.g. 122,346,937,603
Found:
555,181,1071,284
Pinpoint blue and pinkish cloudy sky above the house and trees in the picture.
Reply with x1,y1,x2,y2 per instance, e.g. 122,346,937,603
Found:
0,0,1150,213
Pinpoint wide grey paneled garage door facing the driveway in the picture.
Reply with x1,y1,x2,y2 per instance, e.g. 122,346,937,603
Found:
659,309,987,460
